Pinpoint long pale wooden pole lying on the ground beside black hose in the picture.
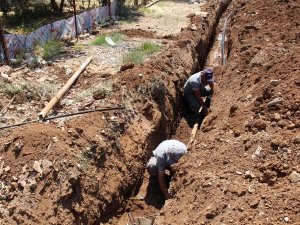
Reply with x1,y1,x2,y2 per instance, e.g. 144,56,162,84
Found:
38,56,93,119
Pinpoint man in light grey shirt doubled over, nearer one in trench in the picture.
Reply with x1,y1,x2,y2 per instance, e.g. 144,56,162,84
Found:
147,140,187,199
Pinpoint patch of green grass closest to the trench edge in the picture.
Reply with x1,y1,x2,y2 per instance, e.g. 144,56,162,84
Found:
123,42,162,64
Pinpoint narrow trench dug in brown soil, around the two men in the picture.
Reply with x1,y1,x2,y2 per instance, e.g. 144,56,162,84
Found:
105,1,230,225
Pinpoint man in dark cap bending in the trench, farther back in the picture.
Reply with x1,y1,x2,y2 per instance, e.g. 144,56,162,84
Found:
184,68,214,115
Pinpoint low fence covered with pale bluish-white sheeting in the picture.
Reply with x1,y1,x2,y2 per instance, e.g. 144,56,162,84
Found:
0,1,117,62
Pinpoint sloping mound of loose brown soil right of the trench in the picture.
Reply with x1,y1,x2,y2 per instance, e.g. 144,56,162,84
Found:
157,0,300,224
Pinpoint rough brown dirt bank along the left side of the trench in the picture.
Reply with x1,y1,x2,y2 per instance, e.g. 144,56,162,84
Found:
0,1,230,224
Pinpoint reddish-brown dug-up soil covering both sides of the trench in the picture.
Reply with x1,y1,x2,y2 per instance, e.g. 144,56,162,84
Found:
0,0,300,224
